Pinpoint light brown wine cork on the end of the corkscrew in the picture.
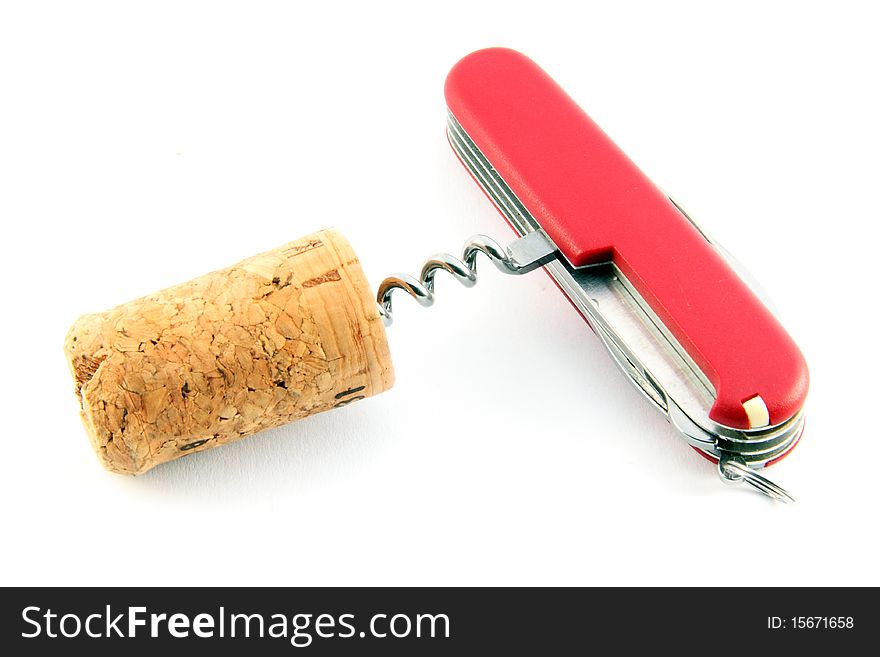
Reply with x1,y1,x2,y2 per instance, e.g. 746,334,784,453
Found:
64,229,394,474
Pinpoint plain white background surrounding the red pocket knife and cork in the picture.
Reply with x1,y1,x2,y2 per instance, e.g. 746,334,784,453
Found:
0,0,880,585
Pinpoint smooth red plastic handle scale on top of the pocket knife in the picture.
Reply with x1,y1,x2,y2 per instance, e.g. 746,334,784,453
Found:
446,48,809,429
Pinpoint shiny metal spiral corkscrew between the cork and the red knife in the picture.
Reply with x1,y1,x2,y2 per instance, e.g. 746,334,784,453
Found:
376,231,556,326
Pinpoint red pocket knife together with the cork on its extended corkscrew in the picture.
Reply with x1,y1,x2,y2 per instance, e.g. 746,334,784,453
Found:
65,48,809,502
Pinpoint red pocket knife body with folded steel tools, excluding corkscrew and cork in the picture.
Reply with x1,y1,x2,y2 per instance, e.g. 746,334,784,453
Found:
436,48,809,501
